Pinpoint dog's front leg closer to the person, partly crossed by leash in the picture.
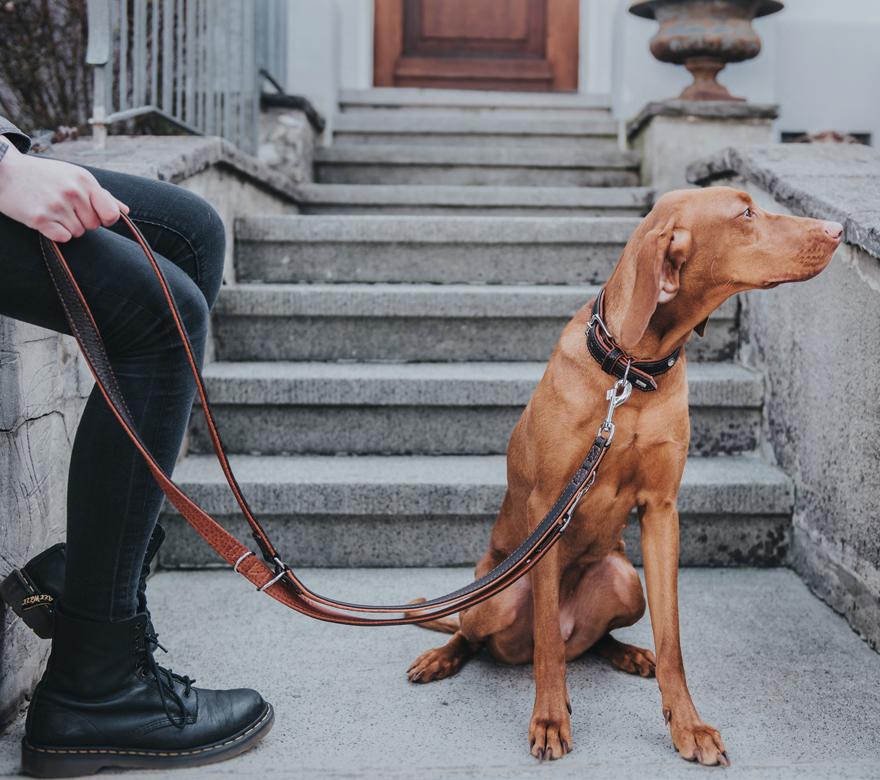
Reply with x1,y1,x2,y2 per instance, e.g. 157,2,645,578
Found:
528,494,572,760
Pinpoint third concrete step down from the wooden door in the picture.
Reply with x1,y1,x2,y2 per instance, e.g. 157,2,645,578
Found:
315,144,639,187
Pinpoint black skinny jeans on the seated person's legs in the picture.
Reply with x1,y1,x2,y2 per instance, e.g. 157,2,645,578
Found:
0,169,225,621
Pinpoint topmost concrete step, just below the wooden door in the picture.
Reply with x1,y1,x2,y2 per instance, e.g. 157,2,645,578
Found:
339,87,611,121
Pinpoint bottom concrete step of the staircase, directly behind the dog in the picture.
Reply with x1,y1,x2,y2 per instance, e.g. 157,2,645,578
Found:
162,455,793,567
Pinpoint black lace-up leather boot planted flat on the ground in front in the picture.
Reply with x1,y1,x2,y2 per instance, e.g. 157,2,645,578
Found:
22,606,274,777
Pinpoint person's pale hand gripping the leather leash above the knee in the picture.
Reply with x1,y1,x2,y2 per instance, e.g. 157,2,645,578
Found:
0,136,128,242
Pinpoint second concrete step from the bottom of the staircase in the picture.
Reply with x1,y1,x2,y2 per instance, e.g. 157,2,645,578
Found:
189,362,763,455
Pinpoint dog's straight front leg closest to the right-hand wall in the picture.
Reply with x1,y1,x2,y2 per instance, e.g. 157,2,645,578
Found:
640,500,730,766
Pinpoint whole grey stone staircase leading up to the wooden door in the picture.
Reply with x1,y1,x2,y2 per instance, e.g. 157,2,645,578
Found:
156,89,792,567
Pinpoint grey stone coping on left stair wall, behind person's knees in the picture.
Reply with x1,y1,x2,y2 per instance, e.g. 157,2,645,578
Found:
47,135,300,203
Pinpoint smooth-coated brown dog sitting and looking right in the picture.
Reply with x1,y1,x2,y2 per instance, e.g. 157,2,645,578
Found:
408,187,843,765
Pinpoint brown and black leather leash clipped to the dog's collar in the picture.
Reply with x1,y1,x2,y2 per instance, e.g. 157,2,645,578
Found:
40,215,632,626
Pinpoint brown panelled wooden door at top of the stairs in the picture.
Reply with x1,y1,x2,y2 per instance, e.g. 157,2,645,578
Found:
373,0,578,92
